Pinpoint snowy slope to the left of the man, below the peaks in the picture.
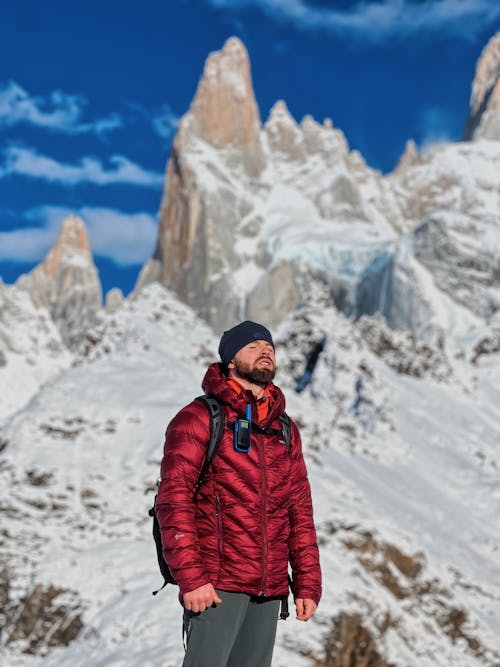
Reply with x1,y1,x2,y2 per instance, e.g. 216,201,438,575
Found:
1,286,214,665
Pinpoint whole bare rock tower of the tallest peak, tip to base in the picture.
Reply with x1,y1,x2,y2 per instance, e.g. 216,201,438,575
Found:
136,38,264,328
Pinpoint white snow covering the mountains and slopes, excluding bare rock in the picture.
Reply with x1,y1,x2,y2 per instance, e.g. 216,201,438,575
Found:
0,91,500,667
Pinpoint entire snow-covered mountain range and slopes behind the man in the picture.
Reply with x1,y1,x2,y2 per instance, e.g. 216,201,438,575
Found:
0,32,500,667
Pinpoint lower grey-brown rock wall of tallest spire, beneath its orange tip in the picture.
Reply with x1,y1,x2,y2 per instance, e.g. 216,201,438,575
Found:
135,107,252,328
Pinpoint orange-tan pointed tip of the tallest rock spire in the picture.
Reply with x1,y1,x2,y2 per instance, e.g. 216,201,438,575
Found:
181,37,262,172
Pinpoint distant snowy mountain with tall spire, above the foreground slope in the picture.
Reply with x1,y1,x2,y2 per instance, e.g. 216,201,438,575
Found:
139,35,500,339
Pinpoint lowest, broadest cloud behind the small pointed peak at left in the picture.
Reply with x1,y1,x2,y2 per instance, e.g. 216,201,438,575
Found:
0,206,158,266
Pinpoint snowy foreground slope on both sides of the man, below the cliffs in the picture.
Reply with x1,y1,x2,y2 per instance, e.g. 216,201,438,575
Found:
0,285,500,667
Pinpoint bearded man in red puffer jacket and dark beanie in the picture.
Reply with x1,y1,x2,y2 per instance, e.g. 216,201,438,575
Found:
156,321,321,667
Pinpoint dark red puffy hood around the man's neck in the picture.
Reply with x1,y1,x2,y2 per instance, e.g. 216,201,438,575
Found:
201,363,285,424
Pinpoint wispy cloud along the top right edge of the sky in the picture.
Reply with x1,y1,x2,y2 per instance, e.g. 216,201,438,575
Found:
205,0,500,40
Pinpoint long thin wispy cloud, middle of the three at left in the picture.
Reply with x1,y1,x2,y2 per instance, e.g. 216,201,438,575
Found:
0,146,163,188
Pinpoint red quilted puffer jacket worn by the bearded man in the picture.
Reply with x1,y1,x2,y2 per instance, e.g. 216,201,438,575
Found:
156,364,321,603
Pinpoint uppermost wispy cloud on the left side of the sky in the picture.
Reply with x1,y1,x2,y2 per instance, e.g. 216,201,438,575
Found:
0,81,123,134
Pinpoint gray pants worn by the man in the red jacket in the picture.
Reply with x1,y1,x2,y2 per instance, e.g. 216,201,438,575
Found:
182,590,280,667
